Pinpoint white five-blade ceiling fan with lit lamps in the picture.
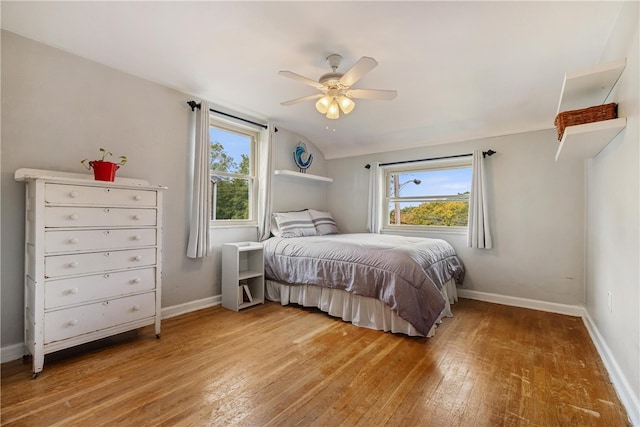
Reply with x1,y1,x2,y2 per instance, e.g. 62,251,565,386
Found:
278,54,398,119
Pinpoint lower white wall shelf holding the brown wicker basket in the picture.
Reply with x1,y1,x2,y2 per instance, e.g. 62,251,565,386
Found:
556,117,627,162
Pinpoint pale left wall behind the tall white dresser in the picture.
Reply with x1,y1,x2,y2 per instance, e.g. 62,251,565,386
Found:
1,31,238,347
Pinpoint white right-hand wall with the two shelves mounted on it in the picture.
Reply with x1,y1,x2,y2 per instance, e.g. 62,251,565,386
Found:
585,2,640,424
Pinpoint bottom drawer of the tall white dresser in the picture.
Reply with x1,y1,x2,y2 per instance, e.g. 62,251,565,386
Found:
44,292,156,344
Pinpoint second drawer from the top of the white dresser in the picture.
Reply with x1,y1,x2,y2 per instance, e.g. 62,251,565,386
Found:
44,206,157,227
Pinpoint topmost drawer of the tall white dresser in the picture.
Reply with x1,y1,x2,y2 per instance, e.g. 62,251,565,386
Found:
44,184,156,207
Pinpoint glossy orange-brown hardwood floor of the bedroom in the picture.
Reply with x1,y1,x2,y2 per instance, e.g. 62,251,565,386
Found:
1,299,629,427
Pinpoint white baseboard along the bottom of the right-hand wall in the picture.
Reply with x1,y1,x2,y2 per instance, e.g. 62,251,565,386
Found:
582,310,640,426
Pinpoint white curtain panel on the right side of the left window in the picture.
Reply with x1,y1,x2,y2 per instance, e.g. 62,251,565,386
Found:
258,124,274,241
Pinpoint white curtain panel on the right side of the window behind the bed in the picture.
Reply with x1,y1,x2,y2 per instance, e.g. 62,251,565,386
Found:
467,149,493,249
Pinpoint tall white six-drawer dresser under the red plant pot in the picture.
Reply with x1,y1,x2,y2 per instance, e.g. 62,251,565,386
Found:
15,169,164,378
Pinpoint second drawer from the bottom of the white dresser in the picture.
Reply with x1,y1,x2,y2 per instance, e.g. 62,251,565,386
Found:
44,267,156,310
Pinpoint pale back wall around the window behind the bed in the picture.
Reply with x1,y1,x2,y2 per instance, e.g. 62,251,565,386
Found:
327,130,584,305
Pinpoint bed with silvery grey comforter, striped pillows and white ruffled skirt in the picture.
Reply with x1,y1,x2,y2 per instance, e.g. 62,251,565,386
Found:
263,211,465,336
